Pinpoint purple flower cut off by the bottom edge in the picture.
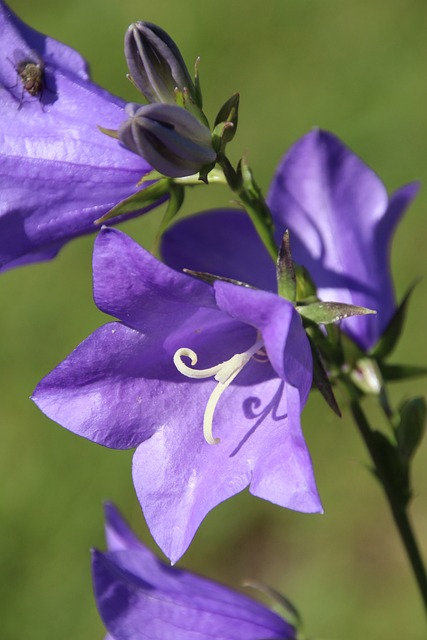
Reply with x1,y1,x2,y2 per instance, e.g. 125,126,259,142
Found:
92,505,295,640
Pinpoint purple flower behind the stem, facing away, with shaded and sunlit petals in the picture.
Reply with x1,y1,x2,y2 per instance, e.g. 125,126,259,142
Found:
163,130,418,349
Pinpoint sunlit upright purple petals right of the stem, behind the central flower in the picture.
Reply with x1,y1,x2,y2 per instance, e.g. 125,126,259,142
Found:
268,130,415,348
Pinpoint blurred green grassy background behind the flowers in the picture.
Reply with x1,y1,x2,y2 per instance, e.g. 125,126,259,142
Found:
0,0,427,640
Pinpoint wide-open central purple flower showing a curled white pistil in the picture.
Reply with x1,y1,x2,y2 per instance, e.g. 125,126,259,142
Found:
33,228,321,562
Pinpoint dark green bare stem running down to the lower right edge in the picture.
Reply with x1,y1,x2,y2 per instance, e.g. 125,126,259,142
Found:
350,399,427,615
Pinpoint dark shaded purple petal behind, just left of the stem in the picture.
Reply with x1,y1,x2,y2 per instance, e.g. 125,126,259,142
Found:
161,209,277,291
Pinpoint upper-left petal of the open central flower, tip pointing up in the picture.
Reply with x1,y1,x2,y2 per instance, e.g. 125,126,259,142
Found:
93,228,216,337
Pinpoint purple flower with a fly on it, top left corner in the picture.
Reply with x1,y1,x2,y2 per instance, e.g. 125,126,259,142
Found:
0,0,159,268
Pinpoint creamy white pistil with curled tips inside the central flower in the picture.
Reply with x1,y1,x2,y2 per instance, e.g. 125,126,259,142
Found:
173,340,265,444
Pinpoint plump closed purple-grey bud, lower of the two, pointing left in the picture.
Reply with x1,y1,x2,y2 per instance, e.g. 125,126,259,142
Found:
119,104,216,178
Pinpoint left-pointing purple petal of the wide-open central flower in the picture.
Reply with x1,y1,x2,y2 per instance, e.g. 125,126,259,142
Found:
33,296,255,449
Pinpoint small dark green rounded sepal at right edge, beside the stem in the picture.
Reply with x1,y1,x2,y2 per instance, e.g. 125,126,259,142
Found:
396,396,426,462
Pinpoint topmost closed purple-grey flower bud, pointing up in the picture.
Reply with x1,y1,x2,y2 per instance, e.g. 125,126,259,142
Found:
125,22,202,110
